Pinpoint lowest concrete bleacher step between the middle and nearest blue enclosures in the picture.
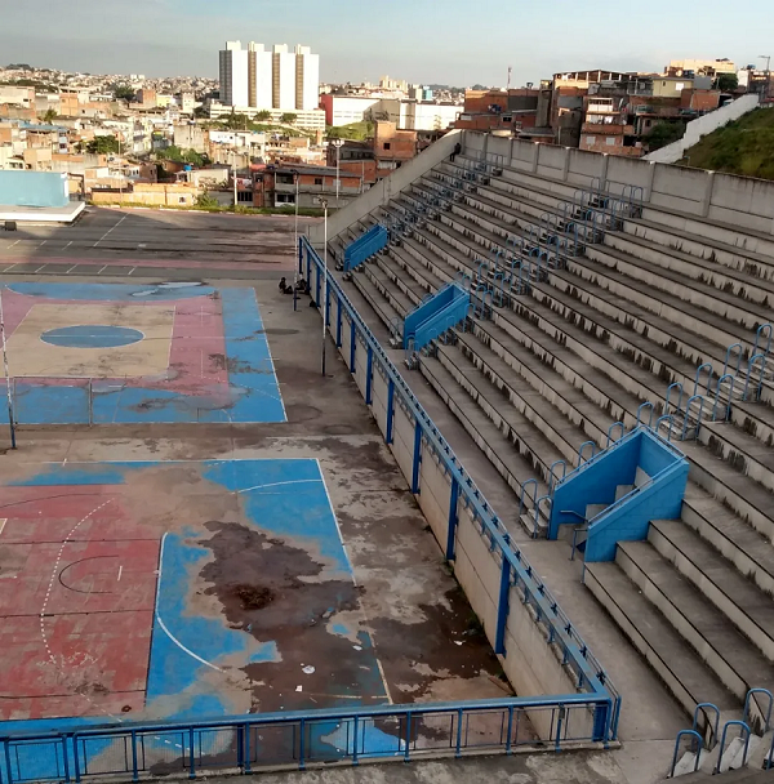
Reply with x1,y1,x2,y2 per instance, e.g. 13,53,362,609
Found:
419,357,548,534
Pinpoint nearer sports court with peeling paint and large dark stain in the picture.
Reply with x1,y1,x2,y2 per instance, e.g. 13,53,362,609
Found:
0,459,388,730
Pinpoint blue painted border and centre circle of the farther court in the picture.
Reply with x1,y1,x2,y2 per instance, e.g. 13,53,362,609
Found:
3,283,286,425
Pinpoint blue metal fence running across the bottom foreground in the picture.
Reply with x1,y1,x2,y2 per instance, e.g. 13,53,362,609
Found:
0,695,604,784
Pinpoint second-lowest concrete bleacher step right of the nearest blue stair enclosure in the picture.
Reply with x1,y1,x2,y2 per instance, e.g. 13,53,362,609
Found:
616,542,774,700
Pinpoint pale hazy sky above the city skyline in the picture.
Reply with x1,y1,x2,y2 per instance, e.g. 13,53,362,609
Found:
0,0,774,87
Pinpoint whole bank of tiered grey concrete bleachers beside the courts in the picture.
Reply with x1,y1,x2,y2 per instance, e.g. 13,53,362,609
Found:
329,150,774,740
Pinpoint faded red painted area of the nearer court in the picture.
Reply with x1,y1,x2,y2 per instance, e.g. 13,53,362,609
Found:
0,485,159,719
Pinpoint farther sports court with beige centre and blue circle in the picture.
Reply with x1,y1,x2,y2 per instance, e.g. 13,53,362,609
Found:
0,283,286,425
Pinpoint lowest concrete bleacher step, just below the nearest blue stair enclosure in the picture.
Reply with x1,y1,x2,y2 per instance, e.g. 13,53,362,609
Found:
583,562,742,718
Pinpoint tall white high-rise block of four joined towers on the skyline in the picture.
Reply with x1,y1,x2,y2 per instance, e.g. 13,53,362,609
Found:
220,41,320,112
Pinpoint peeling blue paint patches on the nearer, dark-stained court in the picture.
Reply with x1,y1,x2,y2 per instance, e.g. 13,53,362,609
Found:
0,460,388,764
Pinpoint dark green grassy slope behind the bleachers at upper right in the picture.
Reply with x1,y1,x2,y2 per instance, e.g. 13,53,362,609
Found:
680,109,774,180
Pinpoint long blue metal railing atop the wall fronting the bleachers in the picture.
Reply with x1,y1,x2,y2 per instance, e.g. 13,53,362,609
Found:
300,237,621,740
